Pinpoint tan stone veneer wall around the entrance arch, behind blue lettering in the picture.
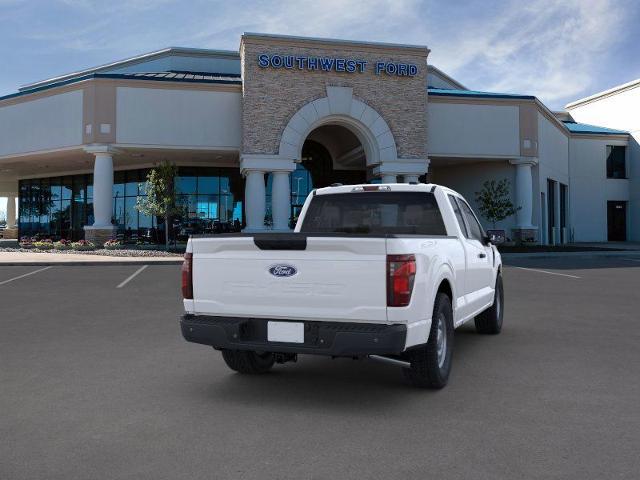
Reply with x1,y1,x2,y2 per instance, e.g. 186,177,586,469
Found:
240,37,428,159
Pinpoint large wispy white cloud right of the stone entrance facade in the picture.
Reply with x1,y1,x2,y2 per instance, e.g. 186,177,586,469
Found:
424,0,626,107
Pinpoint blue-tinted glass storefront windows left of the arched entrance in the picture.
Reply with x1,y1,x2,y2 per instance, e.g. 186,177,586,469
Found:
19,167,244,243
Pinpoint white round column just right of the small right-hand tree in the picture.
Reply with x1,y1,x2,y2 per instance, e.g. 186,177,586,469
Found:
510,157,538,241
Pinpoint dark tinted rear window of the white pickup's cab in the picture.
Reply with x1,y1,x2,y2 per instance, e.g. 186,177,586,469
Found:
300,192,447,235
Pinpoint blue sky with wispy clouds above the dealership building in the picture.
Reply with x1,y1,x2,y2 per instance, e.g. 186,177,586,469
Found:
0,0,640,215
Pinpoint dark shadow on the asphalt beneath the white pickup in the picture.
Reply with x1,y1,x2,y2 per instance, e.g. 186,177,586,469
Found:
199,326,487,414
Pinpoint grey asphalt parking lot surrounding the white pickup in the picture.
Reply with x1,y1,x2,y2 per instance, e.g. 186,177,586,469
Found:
0,257,640,480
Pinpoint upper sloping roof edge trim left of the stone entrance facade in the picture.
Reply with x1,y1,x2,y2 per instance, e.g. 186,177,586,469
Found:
18,47,240,92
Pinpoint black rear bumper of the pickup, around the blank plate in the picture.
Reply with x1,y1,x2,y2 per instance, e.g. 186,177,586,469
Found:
180,315,407,357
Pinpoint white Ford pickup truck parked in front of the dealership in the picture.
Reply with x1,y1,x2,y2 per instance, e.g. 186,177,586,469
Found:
181,184,504,388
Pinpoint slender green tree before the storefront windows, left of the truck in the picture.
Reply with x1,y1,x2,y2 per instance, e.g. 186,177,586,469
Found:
136,160,182,250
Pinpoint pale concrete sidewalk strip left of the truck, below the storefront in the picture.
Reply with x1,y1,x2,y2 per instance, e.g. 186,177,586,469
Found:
0,252,182,268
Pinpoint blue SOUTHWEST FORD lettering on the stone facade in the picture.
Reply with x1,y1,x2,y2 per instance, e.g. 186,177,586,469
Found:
258,53,418,77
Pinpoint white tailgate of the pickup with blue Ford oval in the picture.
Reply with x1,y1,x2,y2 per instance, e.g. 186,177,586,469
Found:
192,234,387,323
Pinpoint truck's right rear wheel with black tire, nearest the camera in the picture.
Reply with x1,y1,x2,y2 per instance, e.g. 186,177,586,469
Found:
403,292,453,388
